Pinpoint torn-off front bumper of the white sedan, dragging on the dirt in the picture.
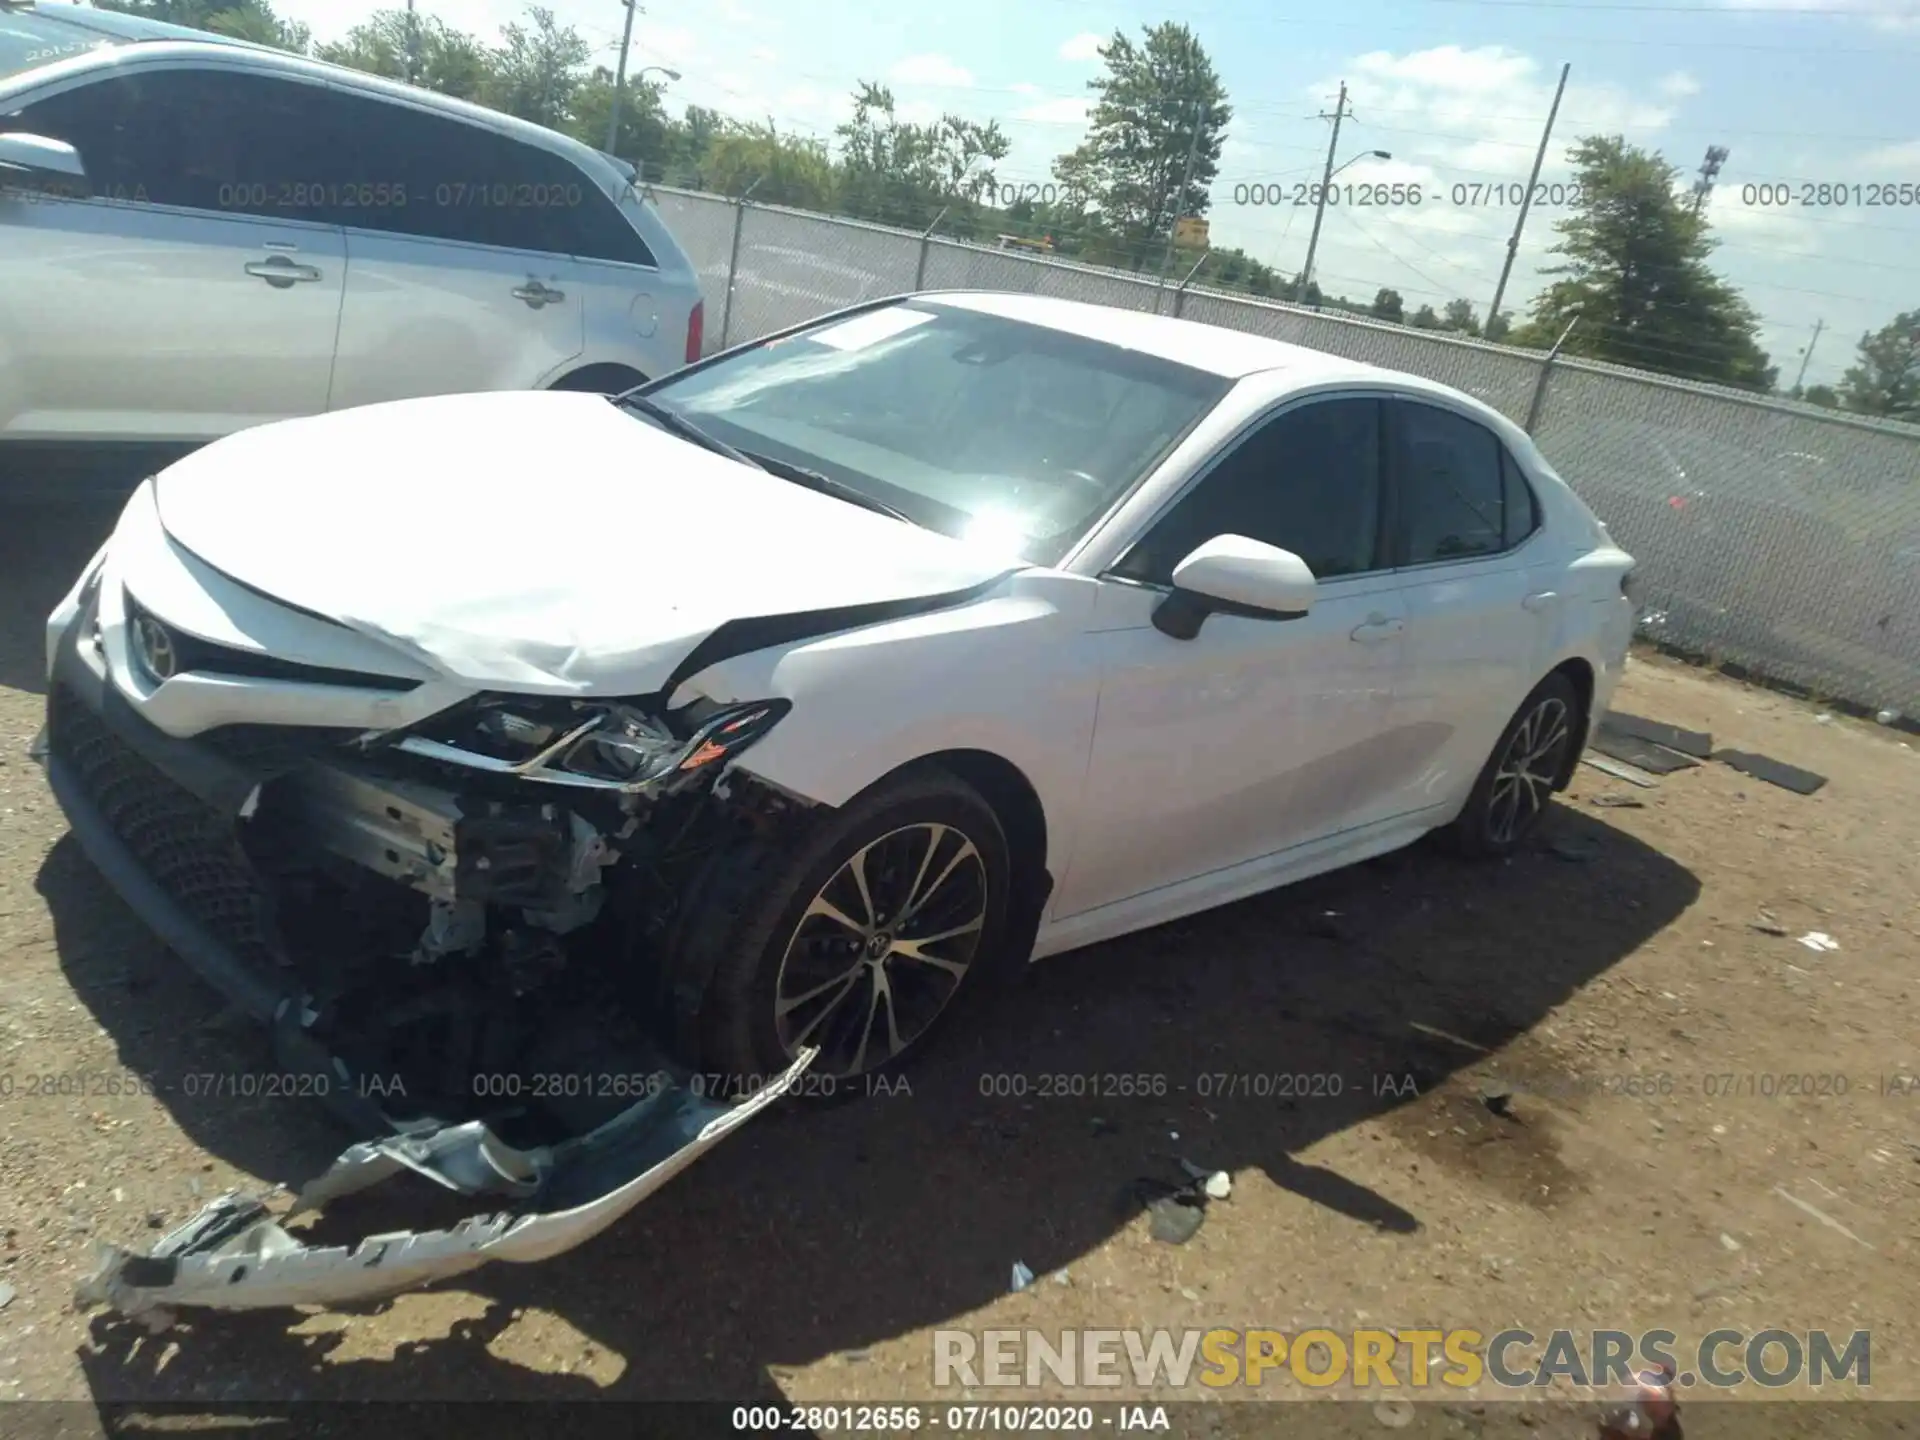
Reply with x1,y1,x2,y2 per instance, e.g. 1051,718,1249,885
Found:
35,614,814,1323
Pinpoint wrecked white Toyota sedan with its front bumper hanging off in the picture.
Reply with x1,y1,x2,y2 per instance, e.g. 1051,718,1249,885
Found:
40,294,1634,1309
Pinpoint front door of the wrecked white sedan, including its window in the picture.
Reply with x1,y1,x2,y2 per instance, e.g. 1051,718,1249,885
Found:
1054,397,1405,920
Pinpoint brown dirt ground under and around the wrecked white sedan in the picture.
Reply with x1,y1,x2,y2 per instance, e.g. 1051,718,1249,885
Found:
0,511,1920,1434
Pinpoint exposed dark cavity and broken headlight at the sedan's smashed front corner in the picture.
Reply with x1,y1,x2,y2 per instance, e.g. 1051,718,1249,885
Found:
244,697,795,1142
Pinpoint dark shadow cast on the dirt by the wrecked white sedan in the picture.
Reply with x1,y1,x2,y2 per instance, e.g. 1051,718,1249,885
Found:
40,804,1699,1405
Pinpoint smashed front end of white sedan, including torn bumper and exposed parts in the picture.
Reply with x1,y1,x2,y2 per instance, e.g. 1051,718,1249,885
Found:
42,616,814,1323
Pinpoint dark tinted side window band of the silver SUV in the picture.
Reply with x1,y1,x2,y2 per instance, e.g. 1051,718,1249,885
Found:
6,69,655,265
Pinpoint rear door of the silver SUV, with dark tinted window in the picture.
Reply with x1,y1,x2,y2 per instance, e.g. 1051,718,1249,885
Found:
328,84,584,411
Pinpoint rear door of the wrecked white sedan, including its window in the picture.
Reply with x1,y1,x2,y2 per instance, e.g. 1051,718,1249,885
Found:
1386,399,1563,808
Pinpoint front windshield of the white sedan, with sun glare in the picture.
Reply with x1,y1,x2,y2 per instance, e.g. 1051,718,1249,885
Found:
647,301,1231,564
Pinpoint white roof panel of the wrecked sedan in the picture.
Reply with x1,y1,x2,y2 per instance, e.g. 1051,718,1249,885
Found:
925,290,1397,384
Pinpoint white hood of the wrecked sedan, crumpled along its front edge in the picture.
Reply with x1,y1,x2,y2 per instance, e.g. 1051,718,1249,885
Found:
156,392,1021,695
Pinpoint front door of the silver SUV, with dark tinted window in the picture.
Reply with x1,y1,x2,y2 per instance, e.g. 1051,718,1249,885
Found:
0,67,346,444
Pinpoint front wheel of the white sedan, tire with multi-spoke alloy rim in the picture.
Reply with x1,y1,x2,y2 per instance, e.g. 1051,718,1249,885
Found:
668,768,1012,1100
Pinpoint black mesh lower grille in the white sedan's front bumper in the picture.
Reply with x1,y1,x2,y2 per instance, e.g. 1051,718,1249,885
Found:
48,685,278,966
